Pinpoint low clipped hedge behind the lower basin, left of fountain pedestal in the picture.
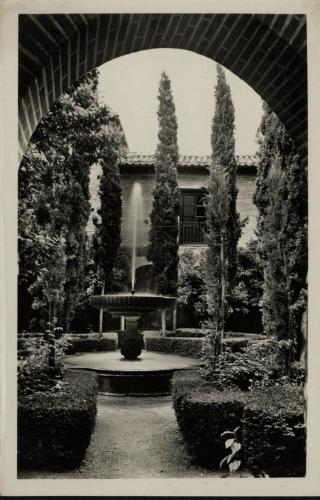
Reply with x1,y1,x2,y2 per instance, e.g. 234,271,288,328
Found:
66,332,118,354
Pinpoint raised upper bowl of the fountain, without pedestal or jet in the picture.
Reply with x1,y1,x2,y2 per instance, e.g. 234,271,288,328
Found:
90,293,176,316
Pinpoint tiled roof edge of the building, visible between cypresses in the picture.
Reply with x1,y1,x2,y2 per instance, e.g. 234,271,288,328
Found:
120,153,257,168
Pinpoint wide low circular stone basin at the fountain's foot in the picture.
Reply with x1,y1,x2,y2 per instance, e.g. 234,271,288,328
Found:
64,351,201,396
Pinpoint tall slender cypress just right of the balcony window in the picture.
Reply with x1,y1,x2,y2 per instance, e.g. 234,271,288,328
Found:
206,65,241,330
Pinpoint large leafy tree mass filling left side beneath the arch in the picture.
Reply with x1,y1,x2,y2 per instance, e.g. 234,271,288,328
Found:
19,70,122,331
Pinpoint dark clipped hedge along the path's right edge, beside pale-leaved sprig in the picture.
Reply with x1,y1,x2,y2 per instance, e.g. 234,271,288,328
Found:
172,370,248,469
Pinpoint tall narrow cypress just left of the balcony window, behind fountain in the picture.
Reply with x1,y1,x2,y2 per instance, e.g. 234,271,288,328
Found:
148,72,180,295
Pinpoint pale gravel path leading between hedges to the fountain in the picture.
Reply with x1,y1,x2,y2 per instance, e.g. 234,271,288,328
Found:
19,395,228,479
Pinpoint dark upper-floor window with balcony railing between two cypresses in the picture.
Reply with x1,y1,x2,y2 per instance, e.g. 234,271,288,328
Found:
180,189,205,244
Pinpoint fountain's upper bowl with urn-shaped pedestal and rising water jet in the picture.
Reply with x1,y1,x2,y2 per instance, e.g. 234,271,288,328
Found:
90,182,175,360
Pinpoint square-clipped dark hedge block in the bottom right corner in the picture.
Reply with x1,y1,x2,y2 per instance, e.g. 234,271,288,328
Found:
243,385,306,477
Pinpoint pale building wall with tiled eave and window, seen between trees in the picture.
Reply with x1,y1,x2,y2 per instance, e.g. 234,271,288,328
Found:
88,153,257,282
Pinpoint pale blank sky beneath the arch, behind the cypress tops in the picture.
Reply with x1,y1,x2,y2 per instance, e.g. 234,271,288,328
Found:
99,49,262,155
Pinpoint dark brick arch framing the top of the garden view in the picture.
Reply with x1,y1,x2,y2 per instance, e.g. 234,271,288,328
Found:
19,13,307,160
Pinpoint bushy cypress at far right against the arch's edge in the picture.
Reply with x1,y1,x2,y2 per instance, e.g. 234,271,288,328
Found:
254,104,308,360
